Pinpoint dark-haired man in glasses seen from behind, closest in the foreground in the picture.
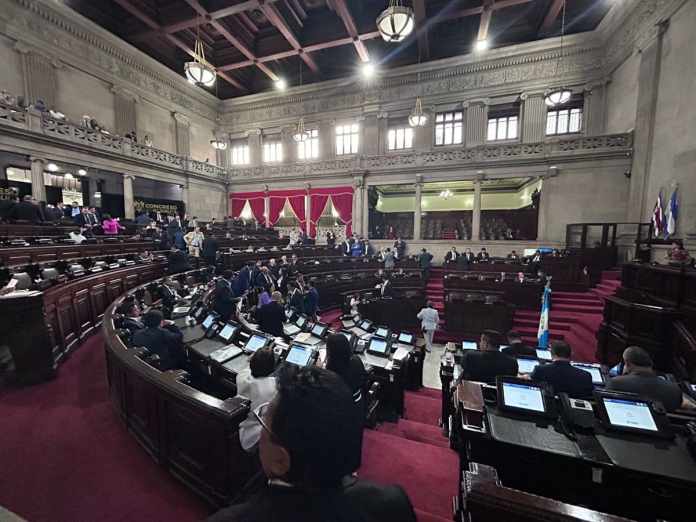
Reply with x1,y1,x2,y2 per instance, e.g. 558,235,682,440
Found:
208,365,416,522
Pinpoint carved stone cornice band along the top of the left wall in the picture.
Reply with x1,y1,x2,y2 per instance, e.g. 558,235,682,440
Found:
0,0,219,121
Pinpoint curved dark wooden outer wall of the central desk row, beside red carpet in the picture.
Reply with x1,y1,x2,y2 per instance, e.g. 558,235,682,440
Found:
103,280,255,506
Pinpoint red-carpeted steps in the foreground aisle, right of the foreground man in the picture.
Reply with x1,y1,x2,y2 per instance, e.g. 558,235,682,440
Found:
359,388,459,522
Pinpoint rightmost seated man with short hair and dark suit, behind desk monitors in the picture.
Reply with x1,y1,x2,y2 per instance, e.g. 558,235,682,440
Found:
607,346,689,411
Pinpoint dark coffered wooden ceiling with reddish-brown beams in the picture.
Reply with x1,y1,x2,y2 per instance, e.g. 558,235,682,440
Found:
65,0,612,99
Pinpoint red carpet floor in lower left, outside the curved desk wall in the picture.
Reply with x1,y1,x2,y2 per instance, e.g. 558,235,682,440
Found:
0,335,209,522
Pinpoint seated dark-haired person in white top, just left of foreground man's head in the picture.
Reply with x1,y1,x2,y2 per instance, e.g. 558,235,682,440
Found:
237,348,276,453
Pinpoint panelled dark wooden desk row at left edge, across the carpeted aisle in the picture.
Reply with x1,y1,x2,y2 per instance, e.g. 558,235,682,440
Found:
0,263,165,384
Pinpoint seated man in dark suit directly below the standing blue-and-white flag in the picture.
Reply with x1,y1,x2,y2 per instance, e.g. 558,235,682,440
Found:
530,341,593,397
